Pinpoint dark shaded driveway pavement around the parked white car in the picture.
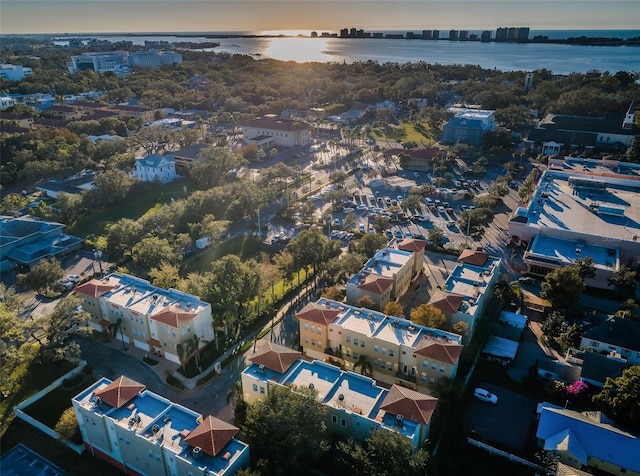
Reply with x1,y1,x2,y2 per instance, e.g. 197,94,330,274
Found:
467,383,538,450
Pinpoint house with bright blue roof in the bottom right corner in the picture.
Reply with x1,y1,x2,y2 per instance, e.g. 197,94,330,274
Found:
536,405,640,476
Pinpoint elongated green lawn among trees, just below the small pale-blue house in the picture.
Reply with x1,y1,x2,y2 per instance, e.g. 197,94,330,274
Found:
67,177,195,237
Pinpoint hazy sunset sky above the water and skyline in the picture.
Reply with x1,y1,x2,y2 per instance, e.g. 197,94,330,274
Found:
0,0,640,34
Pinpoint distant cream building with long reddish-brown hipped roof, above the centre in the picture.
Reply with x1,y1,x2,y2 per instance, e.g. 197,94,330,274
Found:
240,114,311,150
